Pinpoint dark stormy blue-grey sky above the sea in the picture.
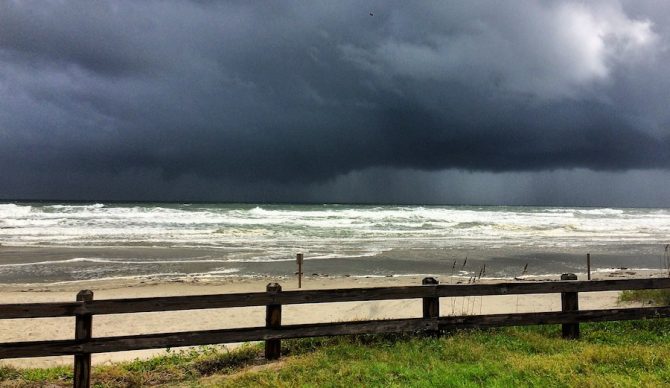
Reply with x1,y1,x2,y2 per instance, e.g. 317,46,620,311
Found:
0,0,670,206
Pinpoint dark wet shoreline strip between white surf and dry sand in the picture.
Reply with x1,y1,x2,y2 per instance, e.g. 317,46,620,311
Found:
0,246,662,284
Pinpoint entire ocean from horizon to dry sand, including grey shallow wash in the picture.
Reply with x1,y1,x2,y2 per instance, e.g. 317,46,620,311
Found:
0,203,670,284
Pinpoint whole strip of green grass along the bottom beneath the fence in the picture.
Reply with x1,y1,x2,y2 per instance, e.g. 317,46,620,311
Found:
0,319,670,387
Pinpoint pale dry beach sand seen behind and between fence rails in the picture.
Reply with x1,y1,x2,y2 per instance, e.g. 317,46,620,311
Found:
0,269,659,367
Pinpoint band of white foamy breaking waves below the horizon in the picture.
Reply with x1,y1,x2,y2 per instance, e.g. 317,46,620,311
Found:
0,203,670,255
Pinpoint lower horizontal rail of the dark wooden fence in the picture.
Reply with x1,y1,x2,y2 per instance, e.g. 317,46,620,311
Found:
0,306,670,359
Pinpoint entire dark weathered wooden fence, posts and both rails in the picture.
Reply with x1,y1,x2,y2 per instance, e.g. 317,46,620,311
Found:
0,274,670,387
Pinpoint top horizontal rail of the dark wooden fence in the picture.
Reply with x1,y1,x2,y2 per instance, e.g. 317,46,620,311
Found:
0,278,670,319
